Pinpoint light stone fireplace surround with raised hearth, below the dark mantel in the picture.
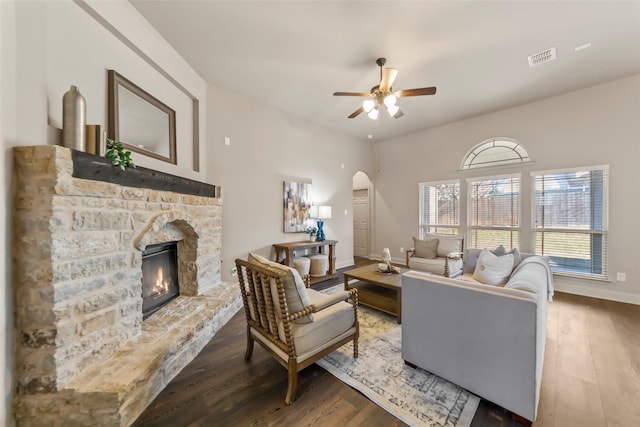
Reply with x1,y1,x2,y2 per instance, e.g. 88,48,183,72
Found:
13,145,242,426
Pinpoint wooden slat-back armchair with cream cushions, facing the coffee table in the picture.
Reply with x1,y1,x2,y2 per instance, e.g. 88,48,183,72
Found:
236,254,359,405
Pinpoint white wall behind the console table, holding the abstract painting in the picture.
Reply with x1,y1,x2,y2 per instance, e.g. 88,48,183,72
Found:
207,86,373,280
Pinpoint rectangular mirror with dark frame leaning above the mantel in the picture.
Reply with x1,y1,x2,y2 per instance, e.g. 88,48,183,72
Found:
107,70,177,164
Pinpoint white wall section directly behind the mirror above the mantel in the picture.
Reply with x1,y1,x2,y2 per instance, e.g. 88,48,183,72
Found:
45,0,206,181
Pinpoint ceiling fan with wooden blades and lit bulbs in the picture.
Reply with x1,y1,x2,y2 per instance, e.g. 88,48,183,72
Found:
333,58,436,120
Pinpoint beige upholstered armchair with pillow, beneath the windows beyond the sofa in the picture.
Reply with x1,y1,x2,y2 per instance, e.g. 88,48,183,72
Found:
406,233,464,277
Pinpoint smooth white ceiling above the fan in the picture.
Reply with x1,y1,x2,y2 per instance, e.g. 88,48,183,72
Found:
131,0,640,140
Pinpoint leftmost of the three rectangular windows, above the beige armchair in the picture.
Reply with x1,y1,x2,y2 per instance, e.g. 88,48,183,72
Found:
419,180,460,238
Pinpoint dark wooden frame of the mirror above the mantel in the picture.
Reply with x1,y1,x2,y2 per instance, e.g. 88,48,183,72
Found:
107,70,177,165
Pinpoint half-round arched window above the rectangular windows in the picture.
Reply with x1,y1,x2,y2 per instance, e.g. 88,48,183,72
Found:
462,138,531,169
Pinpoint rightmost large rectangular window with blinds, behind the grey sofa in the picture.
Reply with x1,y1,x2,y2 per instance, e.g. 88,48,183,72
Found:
531,166,609,280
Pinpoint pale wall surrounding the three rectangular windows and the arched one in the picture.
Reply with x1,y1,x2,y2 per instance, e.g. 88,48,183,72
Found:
375,75,640,304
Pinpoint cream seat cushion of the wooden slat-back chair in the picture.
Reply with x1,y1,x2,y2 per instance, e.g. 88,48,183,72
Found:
279,289,355,355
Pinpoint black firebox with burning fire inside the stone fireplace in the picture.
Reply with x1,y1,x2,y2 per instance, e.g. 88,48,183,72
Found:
142,242,180,319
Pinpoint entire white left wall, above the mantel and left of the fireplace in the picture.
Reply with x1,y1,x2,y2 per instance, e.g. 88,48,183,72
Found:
0,0,206,425
